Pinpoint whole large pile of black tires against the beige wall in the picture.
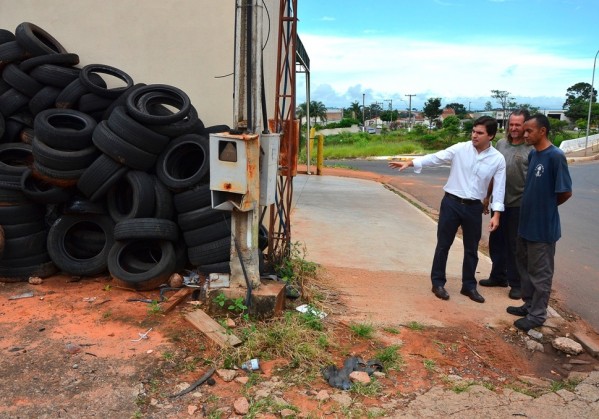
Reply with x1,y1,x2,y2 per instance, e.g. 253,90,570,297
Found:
0,22,266,290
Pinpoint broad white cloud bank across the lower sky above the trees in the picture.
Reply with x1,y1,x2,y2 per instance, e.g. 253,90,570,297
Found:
298,35,591,106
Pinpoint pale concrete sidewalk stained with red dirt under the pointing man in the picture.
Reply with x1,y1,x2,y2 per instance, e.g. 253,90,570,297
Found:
291,175,560,332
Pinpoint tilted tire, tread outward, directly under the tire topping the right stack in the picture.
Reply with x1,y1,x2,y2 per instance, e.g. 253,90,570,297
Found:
108,106,170,155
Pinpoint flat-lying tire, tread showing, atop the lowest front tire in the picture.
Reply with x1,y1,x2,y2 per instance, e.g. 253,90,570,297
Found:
114,218,179,242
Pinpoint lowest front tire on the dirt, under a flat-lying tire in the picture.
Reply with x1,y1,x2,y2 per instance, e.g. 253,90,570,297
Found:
108,240,176,290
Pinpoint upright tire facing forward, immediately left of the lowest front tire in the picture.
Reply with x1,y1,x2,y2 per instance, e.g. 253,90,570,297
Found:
47,215,114,276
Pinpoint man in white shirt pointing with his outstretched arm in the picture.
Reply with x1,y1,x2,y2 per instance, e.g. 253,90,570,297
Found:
389,116,505,303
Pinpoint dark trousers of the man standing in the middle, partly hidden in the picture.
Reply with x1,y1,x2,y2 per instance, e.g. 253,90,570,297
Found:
489,207,520,288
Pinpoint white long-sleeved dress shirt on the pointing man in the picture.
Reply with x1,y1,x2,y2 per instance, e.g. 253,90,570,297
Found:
413,141,505,211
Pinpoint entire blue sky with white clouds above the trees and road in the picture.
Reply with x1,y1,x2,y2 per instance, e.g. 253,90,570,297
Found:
297,0,599,110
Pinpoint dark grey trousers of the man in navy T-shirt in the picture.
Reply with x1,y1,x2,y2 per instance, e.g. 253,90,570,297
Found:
518,237,555,326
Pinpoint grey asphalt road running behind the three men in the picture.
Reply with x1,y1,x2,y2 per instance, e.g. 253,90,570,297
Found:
325,160,599,331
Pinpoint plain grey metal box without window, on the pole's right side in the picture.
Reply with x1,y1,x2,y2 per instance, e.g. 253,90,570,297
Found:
260,134,281,206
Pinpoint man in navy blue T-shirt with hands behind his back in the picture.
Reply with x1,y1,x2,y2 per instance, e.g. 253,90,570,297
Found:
507,114,572,331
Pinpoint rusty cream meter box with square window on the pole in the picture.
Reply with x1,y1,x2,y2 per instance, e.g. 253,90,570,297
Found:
210,133,260,211
